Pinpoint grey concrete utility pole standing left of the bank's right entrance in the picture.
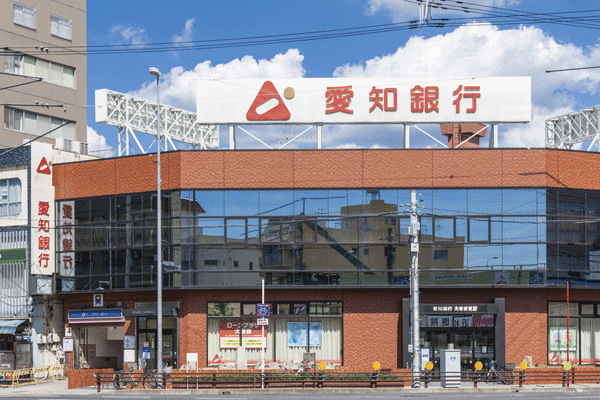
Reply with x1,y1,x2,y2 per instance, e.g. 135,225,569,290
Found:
409,189,421,388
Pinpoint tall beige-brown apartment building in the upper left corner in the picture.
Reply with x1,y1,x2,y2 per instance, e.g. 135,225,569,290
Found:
0,0,87,153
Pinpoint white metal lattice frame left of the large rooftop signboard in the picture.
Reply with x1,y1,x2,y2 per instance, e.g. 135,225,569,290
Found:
96,89,219,156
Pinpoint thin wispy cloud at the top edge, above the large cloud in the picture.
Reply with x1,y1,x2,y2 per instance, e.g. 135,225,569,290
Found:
366,0,519,22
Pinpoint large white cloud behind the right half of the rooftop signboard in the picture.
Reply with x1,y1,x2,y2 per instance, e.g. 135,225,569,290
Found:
334,24,600,147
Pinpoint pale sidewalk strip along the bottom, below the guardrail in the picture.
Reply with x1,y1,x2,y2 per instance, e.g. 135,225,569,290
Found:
0,380,600,398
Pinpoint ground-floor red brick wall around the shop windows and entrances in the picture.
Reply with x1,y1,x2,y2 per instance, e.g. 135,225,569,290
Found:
65,287,600,369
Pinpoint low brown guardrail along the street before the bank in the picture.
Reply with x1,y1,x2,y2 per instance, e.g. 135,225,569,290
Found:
95,367,600,392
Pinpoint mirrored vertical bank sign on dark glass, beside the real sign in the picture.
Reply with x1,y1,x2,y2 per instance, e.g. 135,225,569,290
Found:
56,201,75,276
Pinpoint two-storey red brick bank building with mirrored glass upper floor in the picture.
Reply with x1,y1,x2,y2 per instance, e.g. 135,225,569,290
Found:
53,149,600,368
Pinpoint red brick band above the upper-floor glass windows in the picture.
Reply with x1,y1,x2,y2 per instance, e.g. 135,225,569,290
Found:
53,149,600,199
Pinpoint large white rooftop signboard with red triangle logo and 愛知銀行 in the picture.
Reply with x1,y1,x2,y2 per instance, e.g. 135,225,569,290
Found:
197,77,531,124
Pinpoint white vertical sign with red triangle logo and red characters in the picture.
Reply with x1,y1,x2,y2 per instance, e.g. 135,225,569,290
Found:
30,143,56,275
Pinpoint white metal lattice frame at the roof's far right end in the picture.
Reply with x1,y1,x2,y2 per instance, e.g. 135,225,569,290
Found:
546,105,600,152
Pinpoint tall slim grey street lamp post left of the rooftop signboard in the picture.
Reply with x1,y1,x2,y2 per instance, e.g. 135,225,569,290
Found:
149,67,163,388
